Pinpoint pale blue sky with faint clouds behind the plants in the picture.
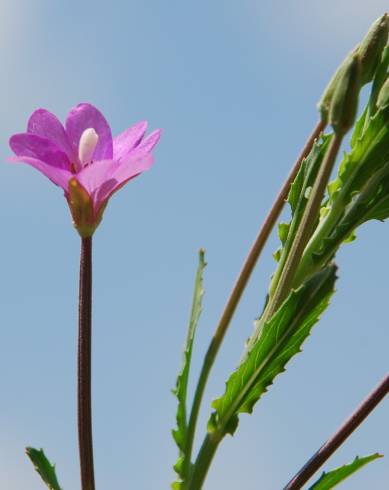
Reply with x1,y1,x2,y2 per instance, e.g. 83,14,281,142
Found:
0,0,389,490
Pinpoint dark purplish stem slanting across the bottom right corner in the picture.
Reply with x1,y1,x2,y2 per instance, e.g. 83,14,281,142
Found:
284,373,389,490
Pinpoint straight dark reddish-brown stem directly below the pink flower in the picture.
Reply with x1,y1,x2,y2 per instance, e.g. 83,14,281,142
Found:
78,236,95,490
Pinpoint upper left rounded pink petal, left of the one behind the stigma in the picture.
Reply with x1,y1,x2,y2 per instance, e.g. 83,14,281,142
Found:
27,109,75,161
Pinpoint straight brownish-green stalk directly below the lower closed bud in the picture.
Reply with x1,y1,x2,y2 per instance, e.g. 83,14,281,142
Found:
264,133,343,321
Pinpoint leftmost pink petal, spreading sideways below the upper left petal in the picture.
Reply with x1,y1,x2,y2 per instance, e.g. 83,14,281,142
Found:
9,133,70,171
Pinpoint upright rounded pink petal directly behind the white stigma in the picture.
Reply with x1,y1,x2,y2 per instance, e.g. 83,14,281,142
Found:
65,103,113,160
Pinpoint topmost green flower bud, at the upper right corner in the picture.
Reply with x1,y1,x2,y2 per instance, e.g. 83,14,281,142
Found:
358,14,389,85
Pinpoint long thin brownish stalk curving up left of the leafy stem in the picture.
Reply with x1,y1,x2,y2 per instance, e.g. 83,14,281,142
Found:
185,121,326,488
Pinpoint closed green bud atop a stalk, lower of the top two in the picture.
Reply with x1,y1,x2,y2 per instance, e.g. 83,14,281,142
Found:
329,54,361,134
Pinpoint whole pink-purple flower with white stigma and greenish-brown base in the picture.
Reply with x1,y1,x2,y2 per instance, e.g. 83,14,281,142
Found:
9,104,161,237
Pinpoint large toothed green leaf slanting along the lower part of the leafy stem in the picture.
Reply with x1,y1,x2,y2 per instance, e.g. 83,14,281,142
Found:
209,265,336,433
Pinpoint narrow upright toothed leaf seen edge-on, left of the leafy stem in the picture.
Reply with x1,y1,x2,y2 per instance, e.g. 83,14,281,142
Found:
172,250,206,485
